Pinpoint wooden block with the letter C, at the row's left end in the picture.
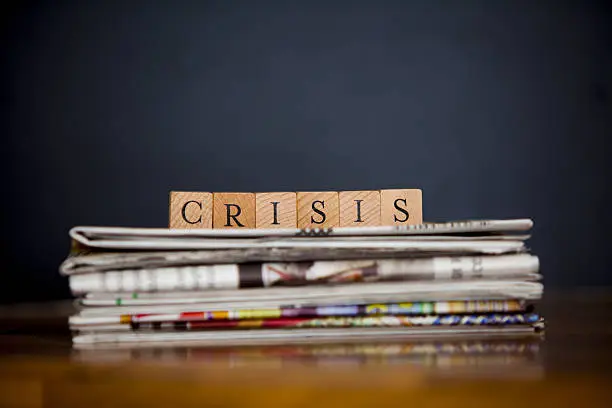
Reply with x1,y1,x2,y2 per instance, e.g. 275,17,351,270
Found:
168,191,212,229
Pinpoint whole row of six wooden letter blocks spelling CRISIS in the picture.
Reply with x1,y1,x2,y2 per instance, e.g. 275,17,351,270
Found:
168,189,423,229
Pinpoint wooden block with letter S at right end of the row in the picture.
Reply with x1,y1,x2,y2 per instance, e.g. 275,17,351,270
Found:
380,189,423,225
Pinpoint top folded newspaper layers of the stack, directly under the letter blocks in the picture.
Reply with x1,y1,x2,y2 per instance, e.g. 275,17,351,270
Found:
60,219,533,275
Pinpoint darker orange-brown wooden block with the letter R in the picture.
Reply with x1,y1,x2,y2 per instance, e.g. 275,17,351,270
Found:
213,193,255,228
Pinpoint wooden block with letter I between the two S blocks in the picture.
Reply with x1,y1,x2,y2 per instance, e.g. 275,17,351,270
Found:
340,191,380,227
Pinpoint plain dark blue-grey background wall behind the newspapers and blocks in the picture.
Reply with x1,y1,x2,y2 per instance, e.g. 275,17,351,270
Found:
0,0,612,302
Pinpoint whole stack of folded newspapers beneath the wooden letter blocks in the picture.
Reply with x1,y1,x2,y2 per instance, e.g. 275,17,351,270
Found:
61,219,543,348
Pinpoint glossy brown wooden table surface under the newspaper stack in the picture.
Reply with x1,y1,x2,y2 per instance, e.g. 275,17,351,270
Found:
0,290,612,408
